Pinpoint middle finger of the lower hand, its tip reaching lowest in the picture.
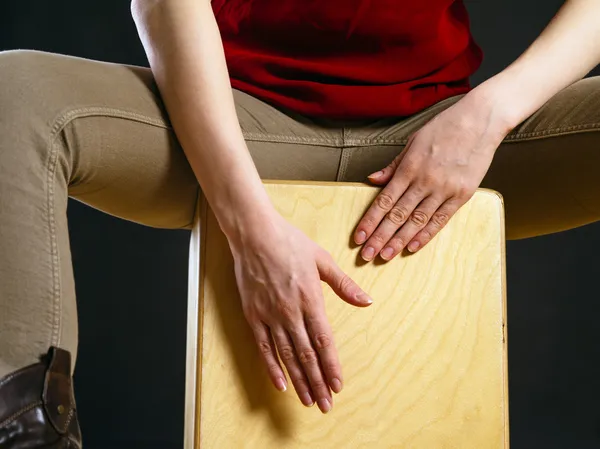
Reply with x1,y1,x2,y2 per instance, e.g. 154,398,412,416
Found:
288,323,333,413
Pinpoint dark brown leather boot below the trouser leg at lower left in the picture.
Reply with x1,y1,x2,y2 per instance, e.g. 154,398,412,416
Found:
0,347,81,449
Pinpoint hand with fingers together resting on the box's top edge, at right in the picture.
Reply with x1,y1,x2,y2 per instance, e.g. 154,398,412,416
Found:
354,91,510,261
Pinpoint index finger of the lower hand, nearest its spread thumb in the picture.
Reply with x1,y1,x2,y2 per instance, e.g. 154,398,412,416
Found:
304,307,343,393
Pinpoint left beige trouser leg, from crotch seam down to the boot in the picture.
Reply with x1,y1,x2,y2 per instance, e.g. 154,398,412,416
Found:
0,51,341,376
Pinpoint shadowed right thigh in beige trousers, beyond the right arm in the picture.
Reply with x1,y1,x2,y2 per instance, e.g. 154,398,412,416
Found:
482,77,600,239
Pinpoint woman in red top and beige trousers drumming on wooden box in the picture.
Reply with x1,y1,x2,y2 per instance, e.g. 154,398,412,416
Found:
0,0,600,447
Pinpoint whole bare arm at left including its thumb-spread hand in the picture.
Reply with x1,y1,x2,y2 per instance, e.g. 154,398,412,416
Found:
132,0,370,413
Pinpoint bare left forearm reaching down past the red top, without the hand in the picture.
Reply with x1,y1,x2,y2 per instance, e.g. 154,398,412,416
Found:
132,0,272,243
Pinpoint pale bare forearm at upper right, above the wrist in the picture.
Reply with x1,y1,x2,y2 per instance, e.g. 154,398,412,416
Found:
471,0,600,129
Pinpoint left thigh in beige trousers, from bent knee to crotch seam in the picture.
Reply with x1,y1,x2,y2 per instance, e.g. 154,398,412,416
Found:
3,51,341,228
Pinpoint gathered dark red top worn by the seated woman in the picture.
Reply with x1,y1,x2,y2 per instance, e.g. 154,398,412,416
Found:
212,0,482,119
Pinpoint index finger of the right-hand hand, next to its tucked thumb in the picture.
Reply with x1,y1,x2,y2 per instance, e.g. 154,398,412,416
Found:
354,172,410,247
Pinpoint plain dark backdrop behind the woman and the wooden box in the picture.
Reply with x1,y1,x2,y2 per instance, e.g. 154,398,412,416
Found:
0,0,600,449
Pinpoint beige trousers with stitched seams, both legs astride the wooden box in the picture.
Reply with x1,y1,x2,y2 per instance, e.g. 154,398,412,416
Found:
0,51,600,376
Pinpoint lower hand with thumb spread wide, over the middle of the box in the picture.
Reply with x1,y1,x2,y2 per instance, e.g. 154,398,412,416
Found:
230,213,372,413
